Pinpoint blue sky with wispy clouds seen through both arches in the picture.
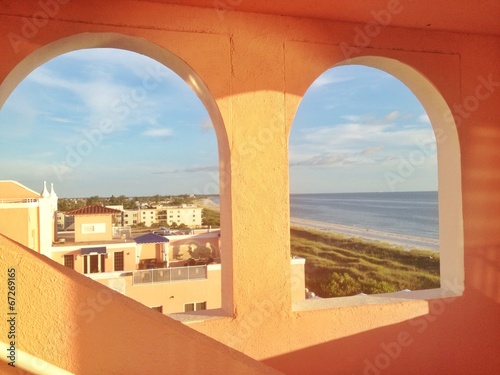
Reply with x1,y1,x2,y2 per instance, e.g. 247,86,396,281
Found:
0,49,437,197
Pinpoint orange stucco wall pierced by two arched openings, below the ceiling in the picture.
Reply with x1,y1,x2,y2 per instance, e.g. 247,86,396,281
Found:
0,1,500,374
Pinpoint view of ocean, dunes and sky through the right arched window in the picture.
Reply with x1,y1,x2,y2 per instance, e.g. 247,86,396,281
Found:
289,58,463,303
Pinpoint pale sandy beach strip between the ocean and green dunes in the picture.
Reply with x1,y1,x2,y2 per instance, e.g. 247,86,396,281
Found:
198,198,439,252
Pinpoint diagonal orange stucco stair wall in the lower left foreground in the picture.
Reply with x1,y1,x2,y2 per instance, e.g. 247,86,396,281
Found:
0,235,278,375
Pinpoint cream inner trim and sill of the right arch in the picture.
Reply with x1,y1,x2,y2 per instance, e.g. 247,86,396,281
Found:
294,56,464,310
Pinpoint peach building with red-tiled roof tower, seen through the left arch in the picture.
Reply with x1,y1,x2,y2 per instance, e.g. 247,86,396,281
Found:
51,205,227,314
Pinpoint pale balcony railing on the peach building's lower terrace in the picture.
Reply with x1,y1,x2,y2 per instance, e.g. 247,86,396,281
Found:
133,266,207,285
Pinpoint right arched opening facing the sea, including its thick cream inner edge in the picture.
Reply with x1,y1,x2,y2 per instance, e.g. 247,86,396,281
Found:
289,57,463,308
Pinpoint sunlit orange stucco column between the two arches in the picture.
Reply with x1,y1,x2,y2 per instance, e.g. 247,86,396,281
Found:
218,35,291,319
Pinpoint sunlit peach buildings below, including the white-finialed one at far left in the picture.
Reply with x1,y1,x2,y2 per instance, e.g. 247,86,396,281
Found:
0,181,298,314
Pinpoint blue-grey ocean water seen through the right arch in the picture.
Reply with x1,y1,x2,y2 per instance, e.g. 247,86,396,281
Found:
290,191,439,240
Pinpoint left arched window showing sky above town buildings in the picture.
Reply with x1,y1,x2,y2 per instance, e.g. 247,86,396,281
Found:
0,48,225,313
